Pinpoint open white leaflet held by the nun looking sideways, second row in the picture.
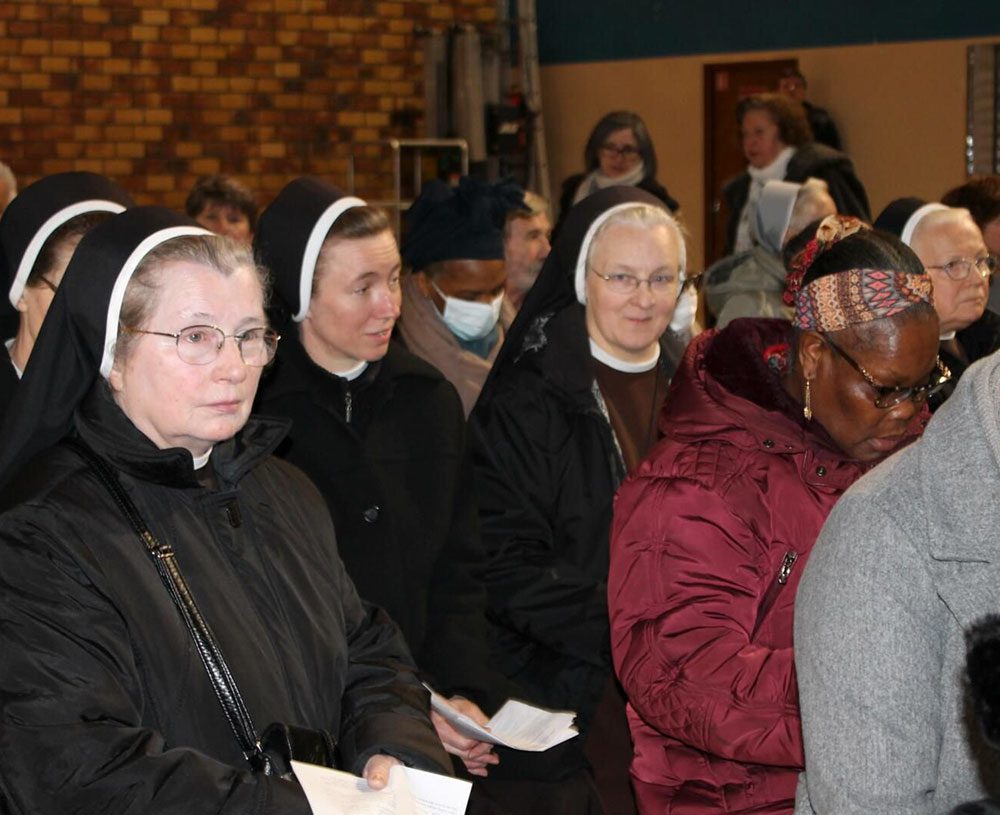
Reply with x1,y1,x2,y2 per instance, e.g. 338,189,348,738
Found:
425,685,579,753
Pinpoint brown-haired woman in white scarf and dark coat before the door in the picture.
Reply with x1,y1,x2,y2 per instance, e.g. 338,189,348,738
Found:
722,93,871,255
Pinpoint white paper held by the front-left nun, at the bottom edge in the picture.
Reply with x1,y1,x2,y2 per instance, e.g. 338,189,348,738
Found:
292,761,472,815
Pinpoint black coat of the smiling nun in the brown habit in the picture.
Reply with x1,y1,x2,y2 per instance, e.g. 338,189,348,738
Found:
469,304,683,731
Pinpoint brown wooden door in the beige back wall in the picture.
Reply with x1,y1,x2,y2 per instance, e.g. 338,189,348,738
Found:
705,59,799,267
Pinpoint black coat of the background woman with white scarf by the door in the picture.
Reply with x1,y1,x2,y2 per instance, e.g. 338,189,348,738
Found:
722,142,872,255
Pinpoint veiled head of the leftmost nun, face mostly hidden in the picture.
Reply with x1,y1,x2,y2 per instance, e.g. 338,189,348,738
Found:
0,172,132,421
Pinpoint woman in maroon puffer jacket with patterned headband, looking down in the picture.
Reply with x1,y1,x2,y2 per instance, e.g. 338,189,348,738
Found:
608,216,948,815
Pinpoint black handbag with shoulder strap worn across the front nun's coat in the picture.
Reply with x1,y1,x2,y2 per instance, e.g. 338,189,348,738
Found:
68,438,338,776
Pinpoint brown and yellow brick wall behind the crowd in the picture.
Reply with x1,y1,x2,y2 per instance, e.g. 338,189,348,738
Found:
0,0,496,208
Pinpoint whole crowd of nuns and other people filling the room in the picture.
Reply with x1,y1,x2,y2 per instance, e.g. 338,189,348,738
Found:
0,65,1000,815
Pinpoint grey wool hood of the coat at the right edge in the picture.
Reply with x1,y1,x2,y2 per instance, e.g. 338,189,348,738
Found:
916,354,1000,562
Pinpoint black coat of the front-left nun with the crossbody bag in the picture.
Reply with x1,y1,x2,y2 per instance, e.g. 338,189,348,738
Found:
0,383,448,815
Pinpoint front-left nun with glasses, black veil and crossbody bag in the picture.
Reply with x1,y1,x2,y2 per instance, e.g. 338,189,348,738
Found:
0,207,449,815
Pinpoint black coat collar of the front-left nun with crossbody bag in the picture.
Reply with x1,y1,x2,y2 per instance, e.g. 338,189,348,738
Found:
75,379,289,488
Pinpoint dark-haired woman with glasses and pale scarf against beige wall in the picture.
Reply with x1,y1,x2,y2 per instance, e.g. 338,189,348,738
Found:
553,110,680,234
